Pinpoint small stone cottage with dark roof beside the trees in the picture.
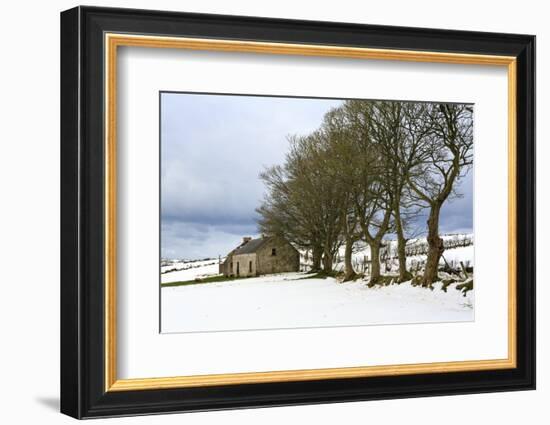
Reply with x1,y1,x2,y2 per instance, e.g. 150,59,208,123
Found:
220,236,300,277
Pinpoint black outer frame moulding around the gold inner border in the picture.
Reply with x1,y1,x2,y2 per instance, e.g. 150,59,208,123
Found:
61,7,535,418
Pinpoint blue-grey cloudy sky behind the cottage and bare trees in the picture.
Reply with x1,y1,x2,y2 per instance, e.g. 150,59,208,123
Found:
161,93,472,259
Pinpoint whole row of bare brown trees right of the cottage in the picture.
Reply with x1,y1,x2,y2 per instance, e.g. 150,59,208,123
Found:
257,100,473,286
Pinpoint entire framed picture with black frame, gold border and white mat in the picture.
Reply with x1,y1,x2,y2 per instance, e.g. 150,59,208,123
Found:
61,7,535,418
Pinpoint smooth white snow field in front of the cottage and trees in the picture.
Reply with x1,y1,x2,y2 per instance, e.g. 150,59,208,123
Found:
161,273,474,332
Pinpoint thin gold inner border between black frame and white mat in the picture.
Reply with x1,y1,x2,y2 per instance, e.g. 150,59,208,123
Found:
104,33,517,391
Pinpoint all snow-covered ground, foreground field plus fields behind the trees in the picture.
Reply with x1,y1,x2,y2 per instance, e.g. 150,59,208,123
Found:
161,235,474,332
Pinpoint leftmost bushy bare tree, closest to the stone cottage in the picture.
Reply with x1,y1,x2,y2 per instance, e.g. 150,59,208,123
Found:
257,130,342,273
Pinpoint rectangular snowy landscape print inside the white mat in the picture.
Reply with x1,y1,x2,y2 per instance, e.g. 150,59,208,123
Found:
160,92,475,333
